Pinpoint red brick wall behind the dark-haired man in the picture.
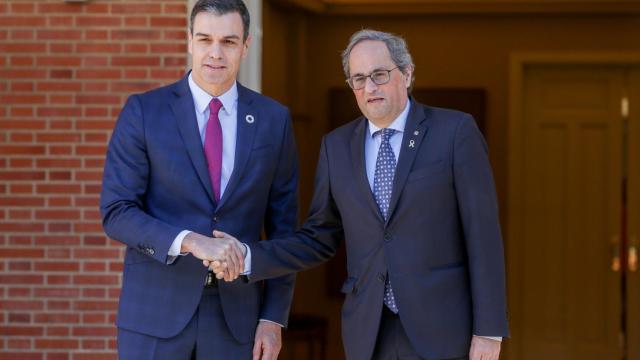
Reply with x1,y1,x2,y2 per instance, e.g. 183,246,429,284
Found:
0,0,187,360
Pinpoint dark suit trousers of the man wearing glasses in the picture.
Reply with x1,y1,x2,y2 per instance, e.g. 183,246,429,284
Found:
372,305,468,360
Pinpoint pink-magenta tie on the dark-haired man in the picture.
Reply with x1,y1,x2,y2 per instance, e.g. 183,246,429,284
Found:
204,98,222,202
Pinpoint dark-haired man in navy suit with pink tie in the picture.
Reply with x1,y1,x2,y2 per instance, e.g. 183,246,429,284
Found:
100,0,298,360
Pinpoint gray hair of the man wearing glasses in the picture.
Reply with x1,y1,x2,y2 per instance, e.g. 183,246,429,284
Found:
342,29,415,83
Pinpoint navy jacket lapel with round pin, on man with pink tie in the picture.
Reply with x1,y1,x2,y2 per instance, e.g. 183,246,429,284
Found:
218,83,260,208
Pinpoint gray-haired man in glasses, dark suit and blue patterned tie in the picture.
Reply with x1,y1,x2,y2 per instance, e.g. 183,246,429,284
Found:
211,30,508,360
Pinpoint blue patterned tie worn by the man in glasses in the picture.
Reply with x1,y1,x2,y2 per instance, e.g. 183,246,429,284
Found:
373,129,398,314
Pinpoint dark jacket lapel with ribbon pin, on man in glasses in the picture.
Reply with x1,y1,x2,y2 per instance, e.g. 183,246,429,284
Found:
387,99,429,223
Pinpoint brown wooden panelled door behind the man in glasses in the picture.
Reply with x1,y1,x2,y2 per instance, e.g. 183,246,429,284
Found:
509,65,625,360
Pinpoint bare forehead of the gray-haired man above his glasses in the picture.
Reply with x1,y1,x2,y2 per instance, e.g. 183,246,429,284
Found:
349,40,395,74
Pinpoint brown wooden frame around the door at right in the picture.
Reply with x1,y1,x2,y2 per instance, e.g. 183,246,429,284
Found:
505,51,640,360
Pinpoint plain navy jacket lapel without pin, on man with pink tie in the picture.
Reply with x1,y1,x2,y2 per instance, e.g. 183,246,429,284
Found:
169,75,215,203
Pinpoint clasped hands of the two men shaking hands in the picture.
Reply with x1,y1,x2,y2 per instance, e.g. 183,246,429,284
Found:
180,230,247,281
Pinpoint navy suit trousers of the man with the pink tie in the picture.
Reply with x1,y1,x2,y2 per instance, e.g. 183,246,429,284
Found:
118,287,253,360
